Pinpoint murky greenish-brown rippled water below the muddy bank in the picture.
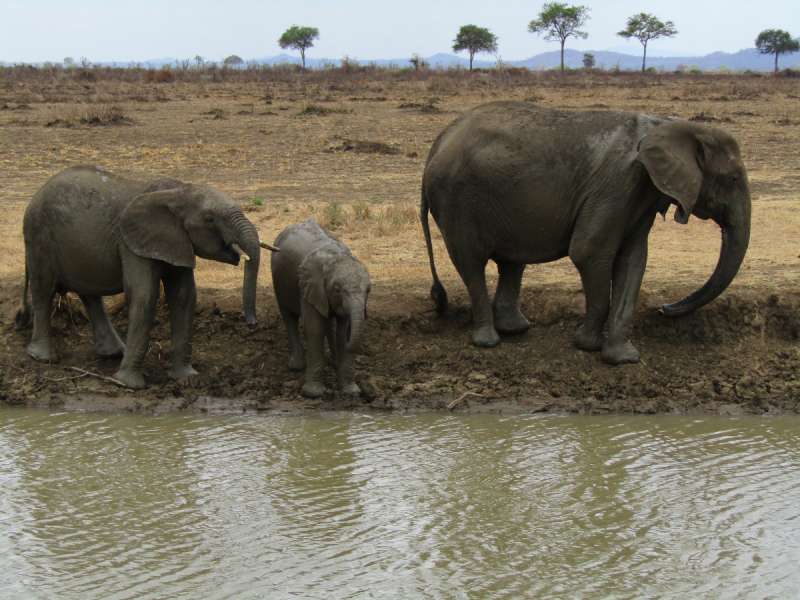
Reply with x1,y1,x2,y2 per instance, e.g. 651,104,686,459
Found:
0,409,800,600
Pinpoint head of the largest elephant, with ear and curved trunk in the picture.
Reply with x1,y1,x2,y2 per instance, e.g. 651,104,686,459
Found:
637,120,750,316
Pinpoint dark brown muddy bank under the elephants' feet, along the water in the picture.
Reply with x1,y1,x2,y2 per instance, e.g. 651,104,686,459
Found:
0,279,800,414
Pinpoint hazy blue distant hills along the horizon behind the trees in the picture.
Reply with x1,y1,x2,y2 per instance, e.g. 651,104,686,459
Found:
112,48,800,71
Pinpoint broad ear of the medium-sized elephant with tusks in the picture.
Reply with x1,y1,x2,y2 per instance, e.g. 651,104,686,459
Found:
119,189,196,269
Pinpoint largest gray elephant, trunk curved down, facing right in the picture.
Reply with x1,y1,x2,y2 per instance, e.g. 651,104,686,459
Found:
421,102,750,364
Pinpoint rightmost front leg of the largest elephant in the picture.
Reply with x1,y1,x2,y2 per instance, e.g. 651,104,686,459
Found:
600,228,649,365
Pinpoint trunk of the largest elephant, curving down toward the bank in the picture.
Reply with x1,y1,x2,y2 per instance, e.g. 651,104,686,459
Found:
660,195,750,317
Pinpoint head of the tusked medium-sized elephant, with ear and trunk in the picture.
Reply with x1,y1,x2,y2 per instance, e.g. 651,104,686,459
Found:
120,184,261,324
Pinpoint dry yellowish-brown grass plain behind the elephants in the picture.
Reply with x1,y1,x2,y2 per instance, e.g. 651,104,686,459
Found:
0,69,800,308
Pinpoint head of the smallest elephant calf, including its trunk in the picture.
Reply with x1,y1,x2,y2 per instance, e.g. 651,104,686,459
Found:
298,249,370,352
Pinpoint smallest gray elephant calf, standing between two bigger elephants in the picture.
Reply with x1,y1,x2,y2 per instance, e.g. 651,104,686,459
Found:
272,219,370,397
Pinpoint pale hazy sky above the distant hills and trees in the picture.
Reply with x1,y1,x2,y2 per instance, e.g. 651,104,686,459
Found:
0,0,800,63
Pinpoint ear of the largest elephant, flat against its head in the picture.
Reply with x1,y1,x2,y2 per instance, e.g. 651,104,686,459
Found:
636,120,705,225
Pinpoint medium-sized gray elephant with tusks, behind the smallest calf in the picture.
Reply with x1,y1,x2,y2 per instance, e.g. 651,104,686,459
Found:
17,165,276,388
